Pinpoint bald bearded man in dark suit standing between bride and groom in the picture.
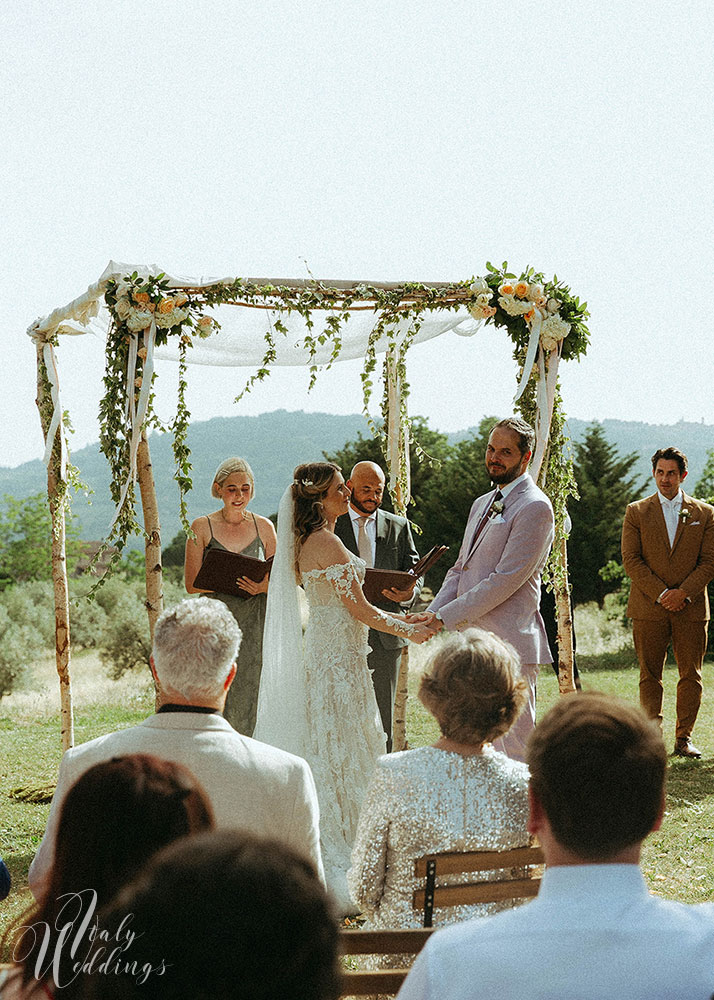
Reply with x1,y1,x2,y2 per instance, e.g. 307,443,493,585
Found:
335,462,423,753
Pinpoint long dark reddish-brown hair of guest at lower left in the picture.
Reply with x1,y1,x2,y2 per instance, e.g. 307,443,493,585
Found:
8,754,214,994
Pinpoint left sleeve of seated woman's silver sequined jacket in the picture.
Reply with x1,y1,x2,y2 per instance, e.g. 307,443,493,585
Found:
347,765,391,915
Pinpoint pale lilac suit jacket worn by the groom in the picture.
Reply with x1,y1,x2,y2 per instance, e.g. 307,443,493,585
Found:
429,476,554,663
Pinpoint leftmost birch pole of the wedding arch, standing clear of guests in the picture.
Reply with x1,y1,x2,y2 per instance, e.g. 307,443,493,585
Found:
35,338,74,751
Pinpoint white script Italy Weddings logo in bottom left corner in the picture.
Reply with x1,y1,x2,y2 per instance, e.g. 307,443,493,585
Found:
13,889,170,990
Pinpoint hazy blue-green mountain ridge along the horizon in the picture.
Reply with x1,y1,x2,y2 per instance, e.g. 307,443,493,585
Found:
0,410,714,545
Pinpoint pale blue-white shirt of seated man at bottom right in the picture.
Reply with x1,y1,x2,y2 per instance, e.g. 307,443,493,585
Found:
398,864,714,1000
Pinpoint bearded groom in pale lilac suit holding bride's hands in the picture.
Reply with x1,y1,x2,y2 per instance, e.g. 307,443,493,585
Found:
425,417,554,760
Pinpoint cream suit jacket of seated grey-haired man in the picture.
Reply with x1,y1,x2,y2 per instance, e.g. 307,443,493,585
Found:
28,712,324,897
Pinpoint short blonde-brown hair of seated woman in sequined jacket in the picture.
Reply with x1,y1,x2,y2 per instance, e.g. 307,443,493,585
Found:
419,628,527,745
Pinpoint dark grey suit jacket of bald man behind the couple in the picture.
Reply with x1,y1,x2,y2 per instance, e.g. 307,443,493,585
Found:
335,510,424,649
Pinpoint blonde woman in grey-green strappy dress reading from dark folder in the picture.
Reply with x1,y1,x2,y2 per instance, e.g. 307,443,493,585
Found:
184,458,276,736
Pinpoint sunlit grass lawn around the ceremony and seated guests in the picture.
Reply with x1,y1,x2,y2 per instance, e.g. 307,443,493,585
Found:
0,651,714,956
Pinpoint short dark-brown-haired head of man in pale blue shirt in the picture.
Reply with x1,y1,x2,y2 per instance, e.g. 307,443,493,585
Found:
526,691,667,864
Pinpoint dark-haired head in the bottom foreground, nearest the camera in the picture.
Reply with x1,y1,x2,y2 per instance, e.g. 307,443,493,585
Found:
73,830,342,1000
